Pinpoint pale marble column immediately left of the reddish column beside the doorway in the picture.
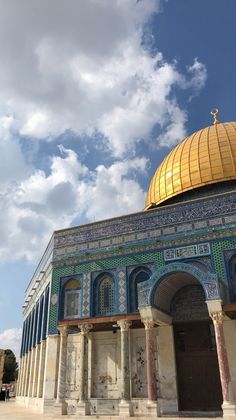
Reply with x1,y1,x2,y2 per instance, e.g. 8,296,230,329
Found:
117,319,132,415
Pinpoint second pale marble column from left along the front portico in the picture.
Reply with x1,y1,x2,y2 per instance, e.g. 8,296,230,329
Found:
77,324,93,415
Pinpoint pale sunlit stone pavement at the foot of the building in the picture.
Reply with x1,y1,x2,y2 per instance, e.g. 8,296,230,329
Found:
0,400,222,420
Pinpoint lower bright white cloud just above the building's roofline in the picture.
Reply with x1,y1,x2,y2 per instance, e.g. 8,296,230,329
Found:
0,146,148,260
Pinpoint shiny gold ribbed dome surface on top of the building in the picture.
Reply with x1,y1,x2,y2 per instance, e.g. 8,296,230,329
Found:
145,122,236,210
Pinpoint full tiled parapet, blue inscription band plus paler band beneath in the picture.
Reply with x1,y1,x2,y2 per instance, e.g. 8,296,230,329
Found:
54,192,236,257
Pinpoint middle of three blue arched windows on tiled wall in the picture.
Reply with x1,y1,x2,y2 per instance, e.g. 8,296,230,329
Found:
95,273,115,315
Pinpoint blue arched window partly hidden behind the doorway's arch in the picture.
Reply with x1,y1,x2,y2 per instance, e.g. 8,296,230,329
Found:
129,267,152,312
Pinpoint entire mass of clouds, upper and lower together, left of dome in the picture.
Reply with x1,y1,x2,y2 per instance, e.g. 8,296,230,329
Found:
0,0,207,260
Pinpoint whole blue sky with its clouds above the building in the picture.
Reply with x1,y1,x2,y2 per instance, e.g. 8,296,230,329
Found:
0,0,236,360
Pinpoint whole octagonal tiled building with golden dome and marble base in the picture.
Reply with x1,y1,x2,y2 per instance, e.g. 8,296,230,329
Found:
17,118,236,420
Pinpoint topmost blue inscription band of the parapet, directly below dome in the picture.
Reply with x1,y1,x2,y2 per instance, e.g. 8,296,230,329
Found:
54,192,236,248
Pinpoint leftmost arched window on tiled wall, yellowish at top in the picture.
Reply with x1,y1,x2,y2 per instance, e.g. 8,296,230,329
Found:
63,278,81,319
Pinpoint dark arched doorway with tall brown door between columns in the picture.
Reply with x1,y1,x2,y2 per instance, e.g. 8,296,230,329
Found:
152,272,222,412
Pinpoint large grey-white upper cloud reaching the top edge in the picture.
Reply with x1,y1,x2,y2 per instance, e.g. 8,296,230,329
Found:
0,0,206,156
